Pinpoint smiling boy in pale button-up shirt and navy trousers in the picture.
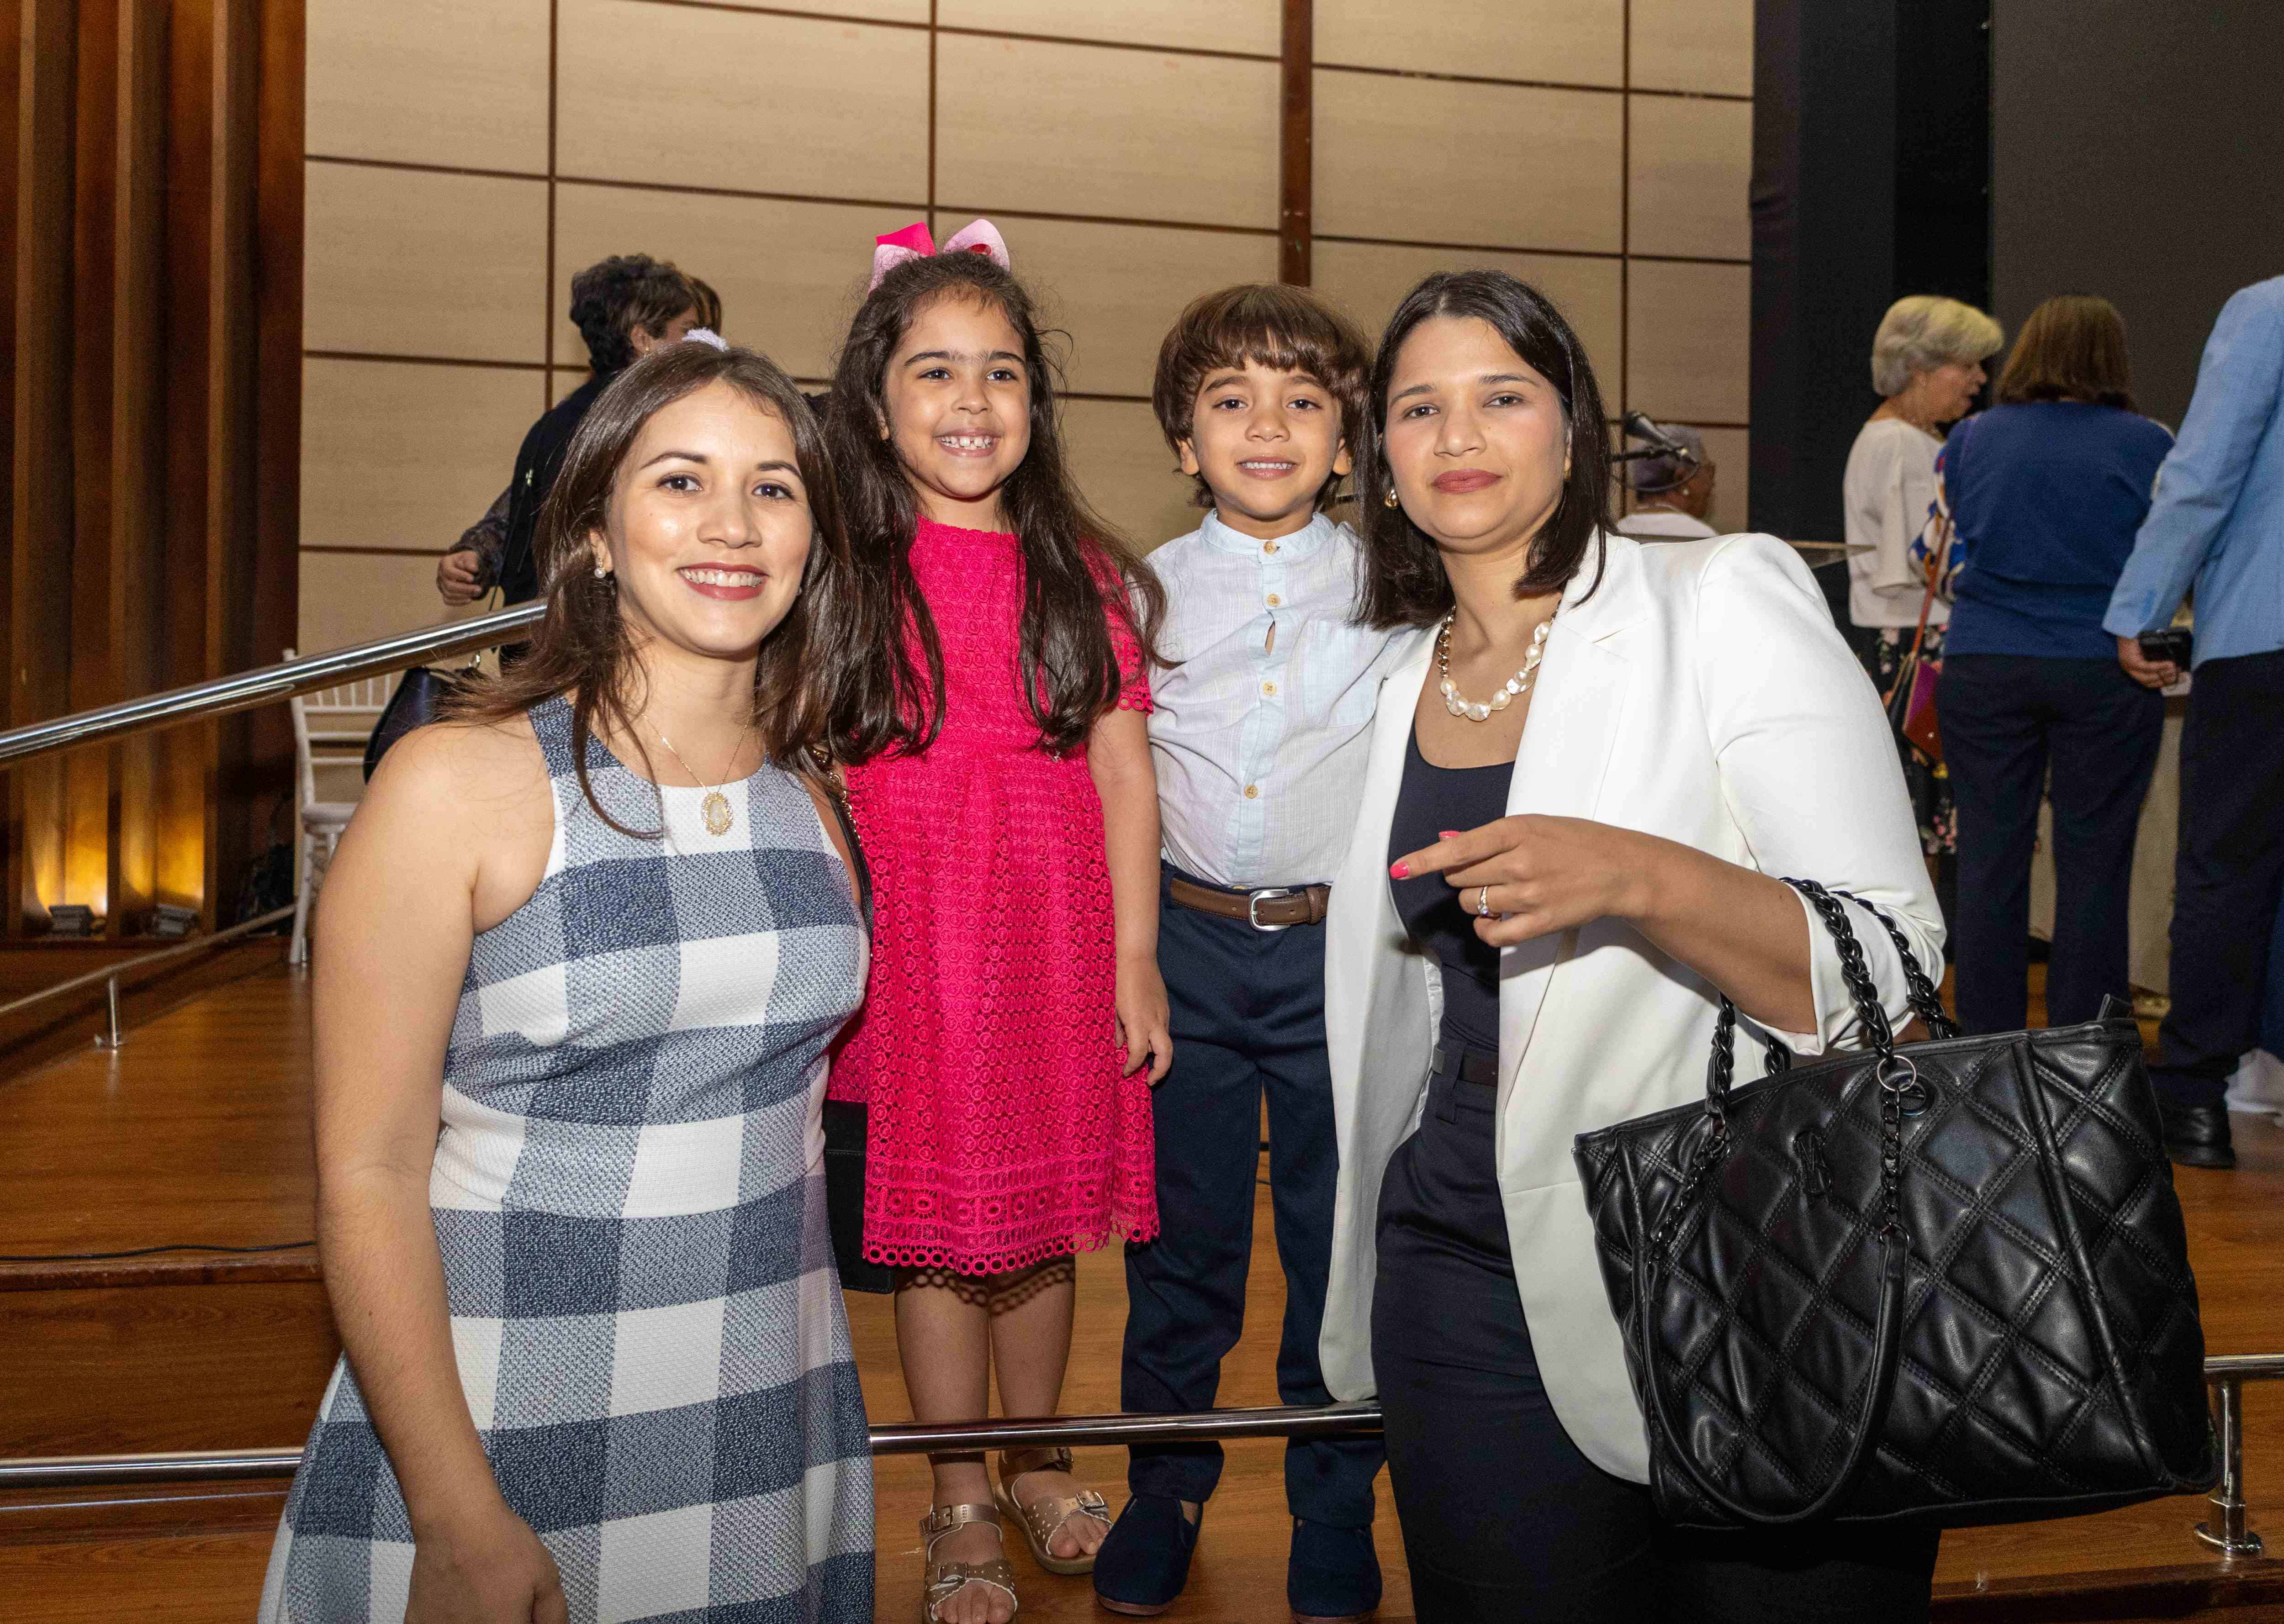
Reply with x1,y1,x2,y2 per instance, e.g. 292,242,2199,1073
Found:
1094,285,1414,1619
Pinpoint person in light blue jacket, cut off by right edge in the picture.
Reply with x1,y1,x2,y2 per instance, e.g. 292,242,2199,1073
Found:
2101,276,2284,1167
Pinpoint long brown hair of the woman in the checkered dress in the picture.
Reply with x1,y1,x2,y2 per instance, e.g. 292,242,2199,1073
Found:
452,343,856,838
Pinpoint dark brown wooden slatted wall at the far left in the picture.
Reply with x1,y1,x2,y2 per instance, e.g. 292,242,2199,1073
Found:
0,0,304,937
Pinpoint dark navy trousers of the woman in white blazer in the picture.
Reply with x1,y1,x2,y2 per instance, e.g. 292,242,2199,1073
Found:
1373,1055,1937,1624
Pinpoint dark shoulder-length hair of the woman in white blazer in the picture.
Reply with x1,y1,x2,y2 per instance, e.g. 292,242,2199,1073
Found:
1357,269,1610,628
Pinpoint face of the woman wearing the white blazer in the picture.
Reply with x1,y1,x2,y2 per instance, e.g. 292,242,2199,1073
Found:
1384,315,1569,553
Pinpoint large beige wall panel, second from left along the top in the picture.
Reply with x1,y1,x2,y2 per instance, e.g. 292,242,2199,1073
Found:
557,0,927,199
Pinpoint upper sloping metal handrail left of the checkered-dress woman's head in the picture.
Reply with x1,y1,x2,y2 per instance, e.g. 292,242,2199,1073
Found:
0,603,548,767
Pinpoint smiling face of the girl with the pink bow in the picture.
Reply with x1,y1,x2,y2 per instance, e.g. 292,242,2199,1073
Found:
882,295,1030,530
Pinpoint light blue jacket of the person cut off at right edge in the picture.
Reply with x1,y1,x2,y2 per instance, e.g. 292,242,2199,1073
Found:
2101,276,2284,664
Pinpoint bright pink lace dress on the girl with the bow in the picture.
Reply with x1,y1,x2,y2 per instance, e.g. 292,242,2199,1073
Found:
829,518,1158,1275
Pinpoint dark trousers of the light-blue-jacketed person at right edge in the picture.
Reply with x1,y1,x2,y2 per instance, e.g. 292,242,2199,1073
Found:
2149,651,2284,1106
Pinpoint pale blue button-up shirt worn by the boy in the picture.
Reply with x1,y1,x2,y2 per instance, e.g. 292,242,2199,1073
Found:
1149,514,1418,891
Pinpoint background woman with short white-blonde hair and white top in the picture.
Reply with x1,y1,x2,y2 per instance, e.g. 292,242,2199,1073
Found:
1841,295,2005,877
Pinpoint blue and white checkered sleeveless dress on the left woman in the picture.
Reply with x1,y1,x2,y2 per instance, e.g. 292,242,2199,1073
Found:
260,699,872,1624
